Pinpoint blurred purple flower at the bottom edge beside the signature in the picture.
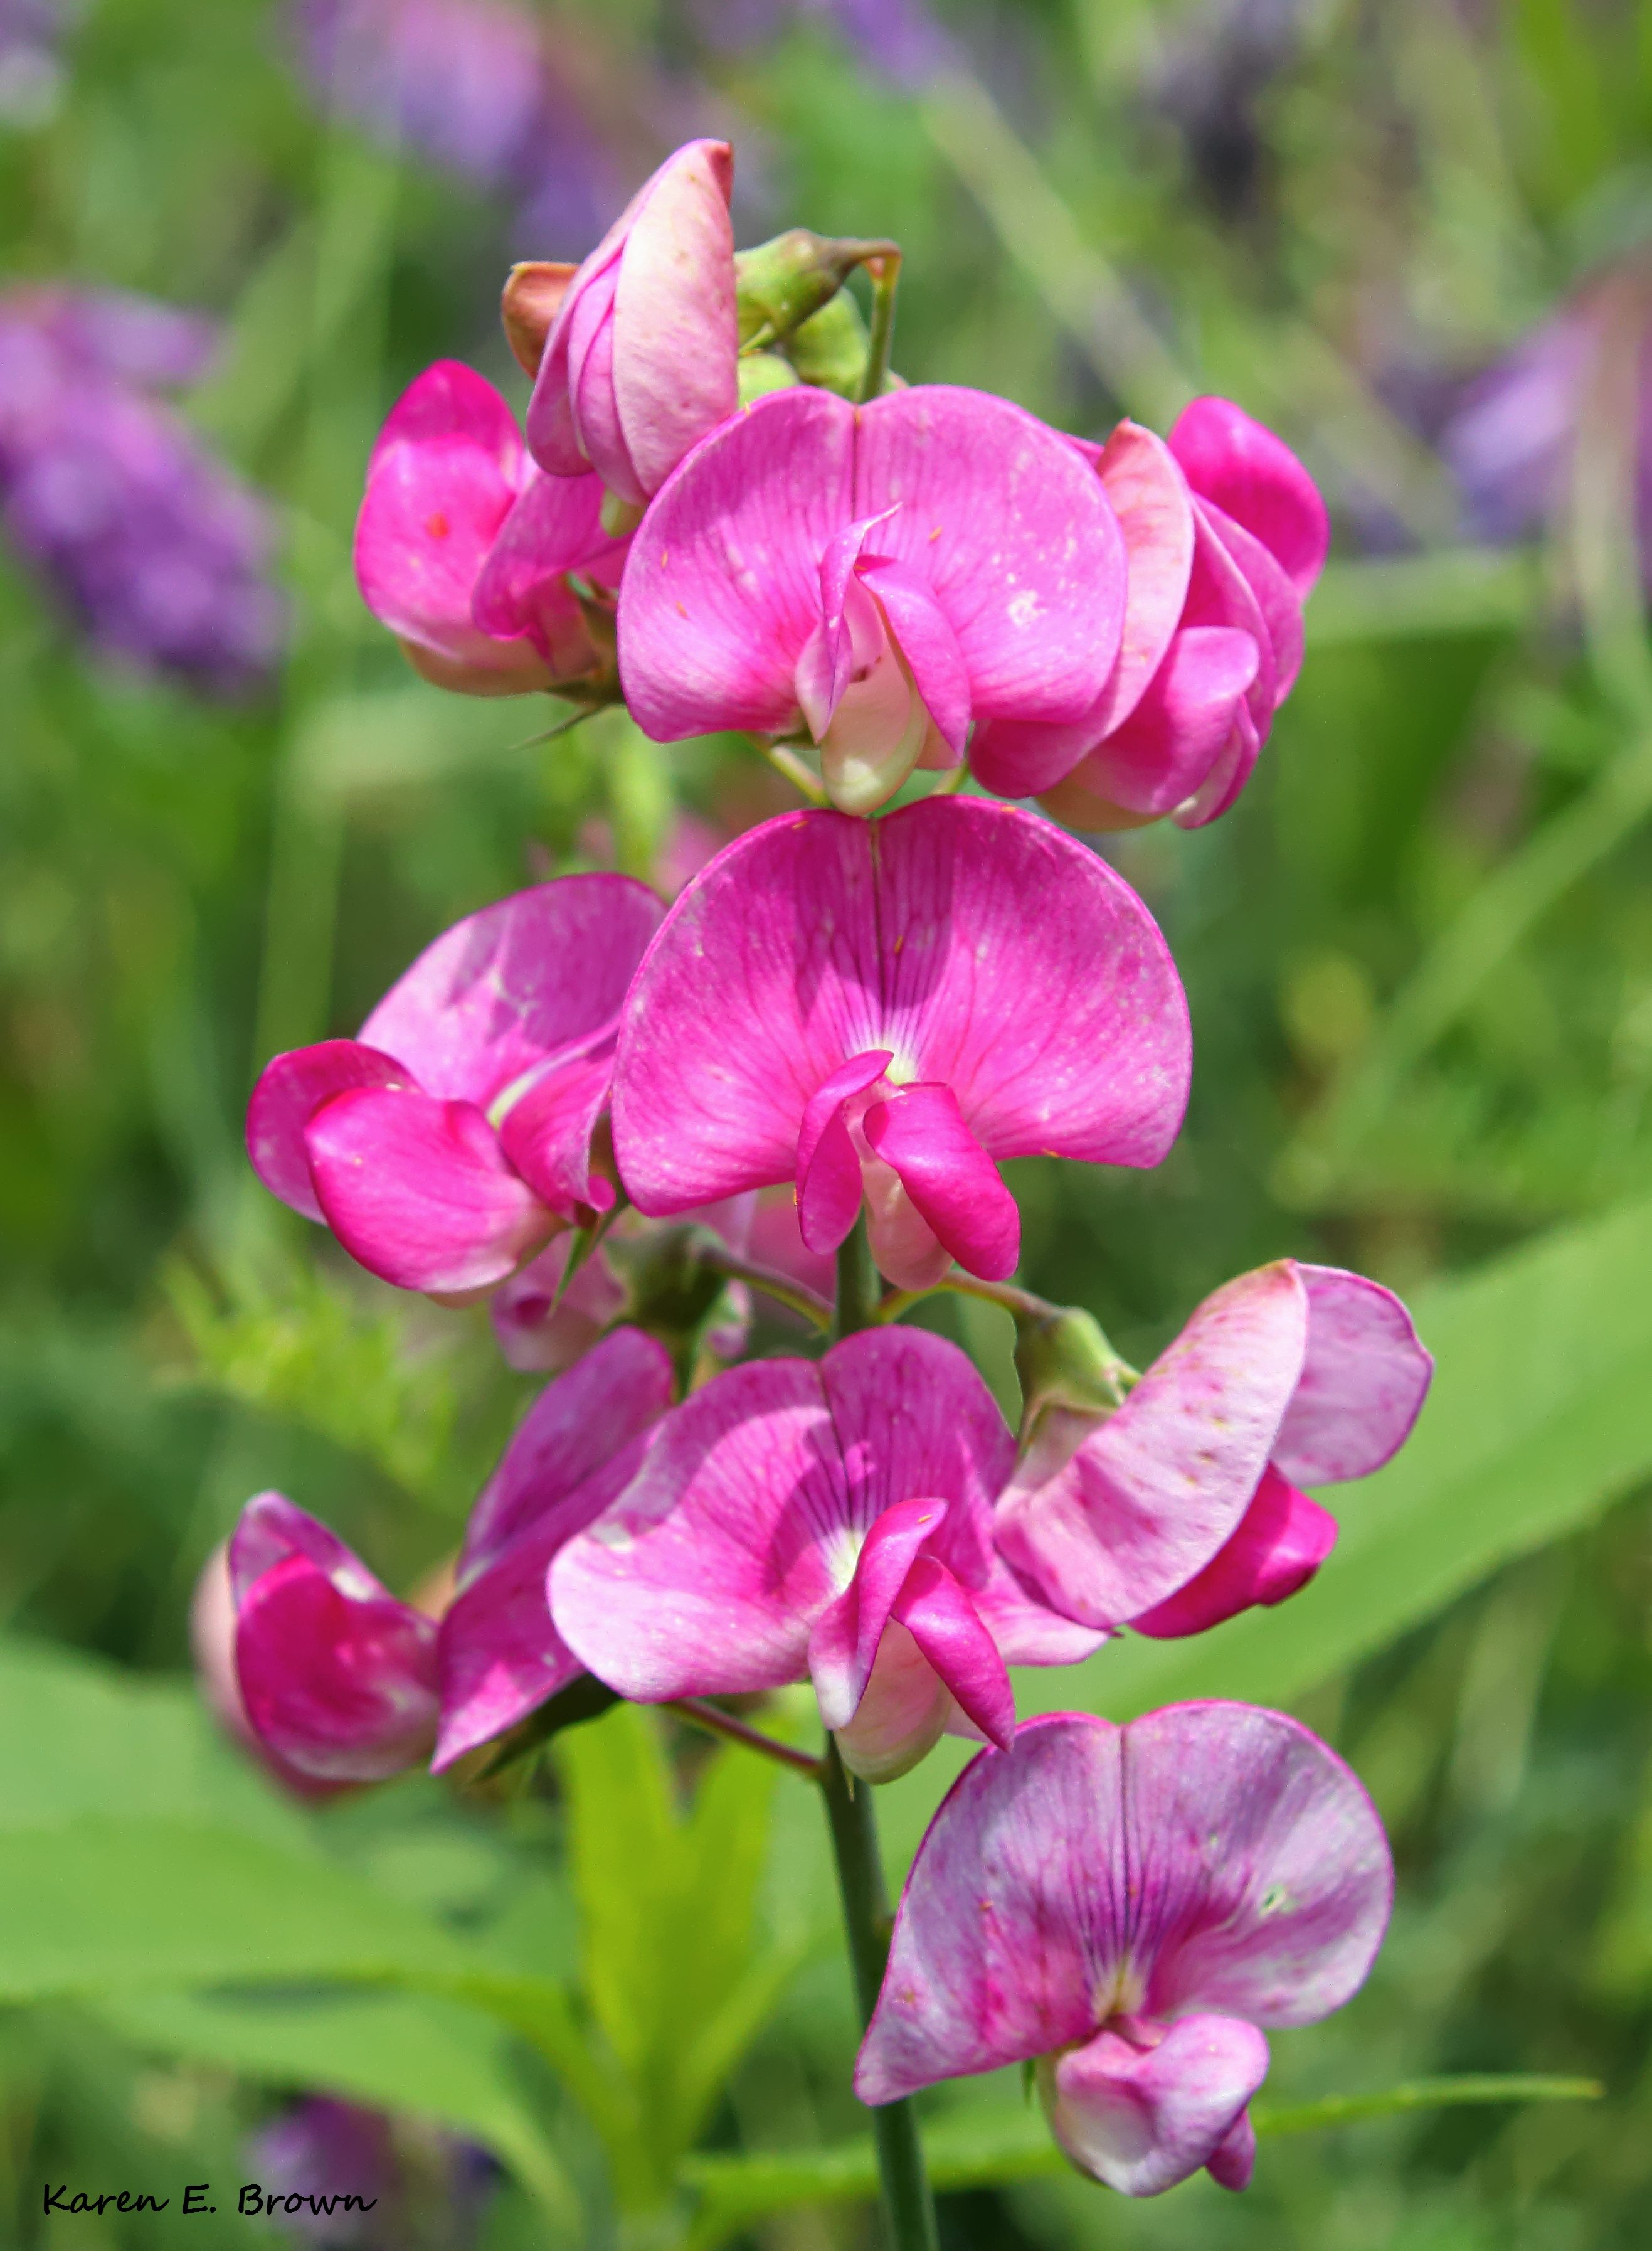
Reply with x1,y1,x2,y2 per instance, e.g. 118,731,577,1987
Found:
248,2095,497,2251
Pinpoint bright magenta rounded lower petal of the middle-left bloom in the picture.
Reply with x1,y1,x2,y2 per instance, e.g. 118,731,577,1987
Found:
304,1087,554,1294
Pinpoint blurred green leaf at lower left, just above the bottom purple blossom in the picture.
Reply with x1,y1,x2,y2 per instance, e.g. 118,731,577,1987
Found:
92,1990,578,2231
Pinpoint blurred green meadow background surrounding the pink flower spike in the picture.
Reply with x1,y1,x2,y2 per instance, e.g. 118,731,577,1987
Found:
0,0,1652,2251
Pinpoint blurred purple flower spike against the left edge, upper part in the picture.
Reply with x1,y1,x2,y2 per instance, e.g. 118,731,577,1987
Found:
0,288,286,696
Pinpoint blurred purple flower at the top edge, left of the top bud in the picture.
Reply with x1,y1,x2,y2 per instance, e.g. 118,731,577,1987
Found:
295,0,623,254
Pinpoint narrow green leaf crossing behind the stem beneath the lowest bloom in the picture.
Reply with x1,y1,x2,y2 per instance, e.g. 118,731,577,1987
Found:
682,2071,1602,2251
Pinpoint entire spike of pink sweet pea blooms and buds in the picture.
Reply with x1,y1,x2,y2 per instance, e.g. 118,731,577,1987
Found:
217,142,1431,2195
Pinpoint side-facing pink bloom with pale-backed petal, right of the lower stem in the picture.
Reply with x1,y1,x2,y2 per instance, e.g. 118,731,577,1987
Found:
997,1259,1434,1639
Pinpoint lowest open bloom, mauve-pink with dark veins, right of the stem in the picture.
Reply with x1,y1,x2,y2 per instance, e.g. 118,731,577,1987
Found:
855,1704,1393,2197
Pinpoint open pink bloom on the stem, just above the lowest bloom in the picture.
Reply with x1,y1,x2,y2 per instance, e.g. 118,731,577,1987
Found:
551,1328,1231,1780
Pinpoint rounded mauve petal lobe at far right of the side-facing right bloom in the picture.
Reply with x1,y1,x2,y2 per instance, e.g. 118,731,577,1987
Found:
1274,1265,1434,1486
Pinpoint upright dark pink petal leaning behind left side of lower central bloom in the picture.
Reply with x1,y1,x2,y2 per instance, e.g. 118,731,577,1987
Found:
459,1328,673,1589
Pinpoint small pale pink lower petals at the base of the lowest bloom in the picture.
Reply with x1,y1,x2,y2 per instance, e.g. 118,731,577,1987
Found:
1040,2014,1267,2197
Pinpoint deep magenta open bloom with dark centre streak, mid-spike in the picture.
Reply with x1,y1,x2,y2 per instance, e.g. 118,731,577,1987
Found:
615,797,1190,1290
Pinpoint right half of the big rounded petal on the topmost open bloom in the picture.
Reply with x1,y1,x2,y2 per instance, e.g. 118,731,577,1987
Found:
855,383,1125,720
